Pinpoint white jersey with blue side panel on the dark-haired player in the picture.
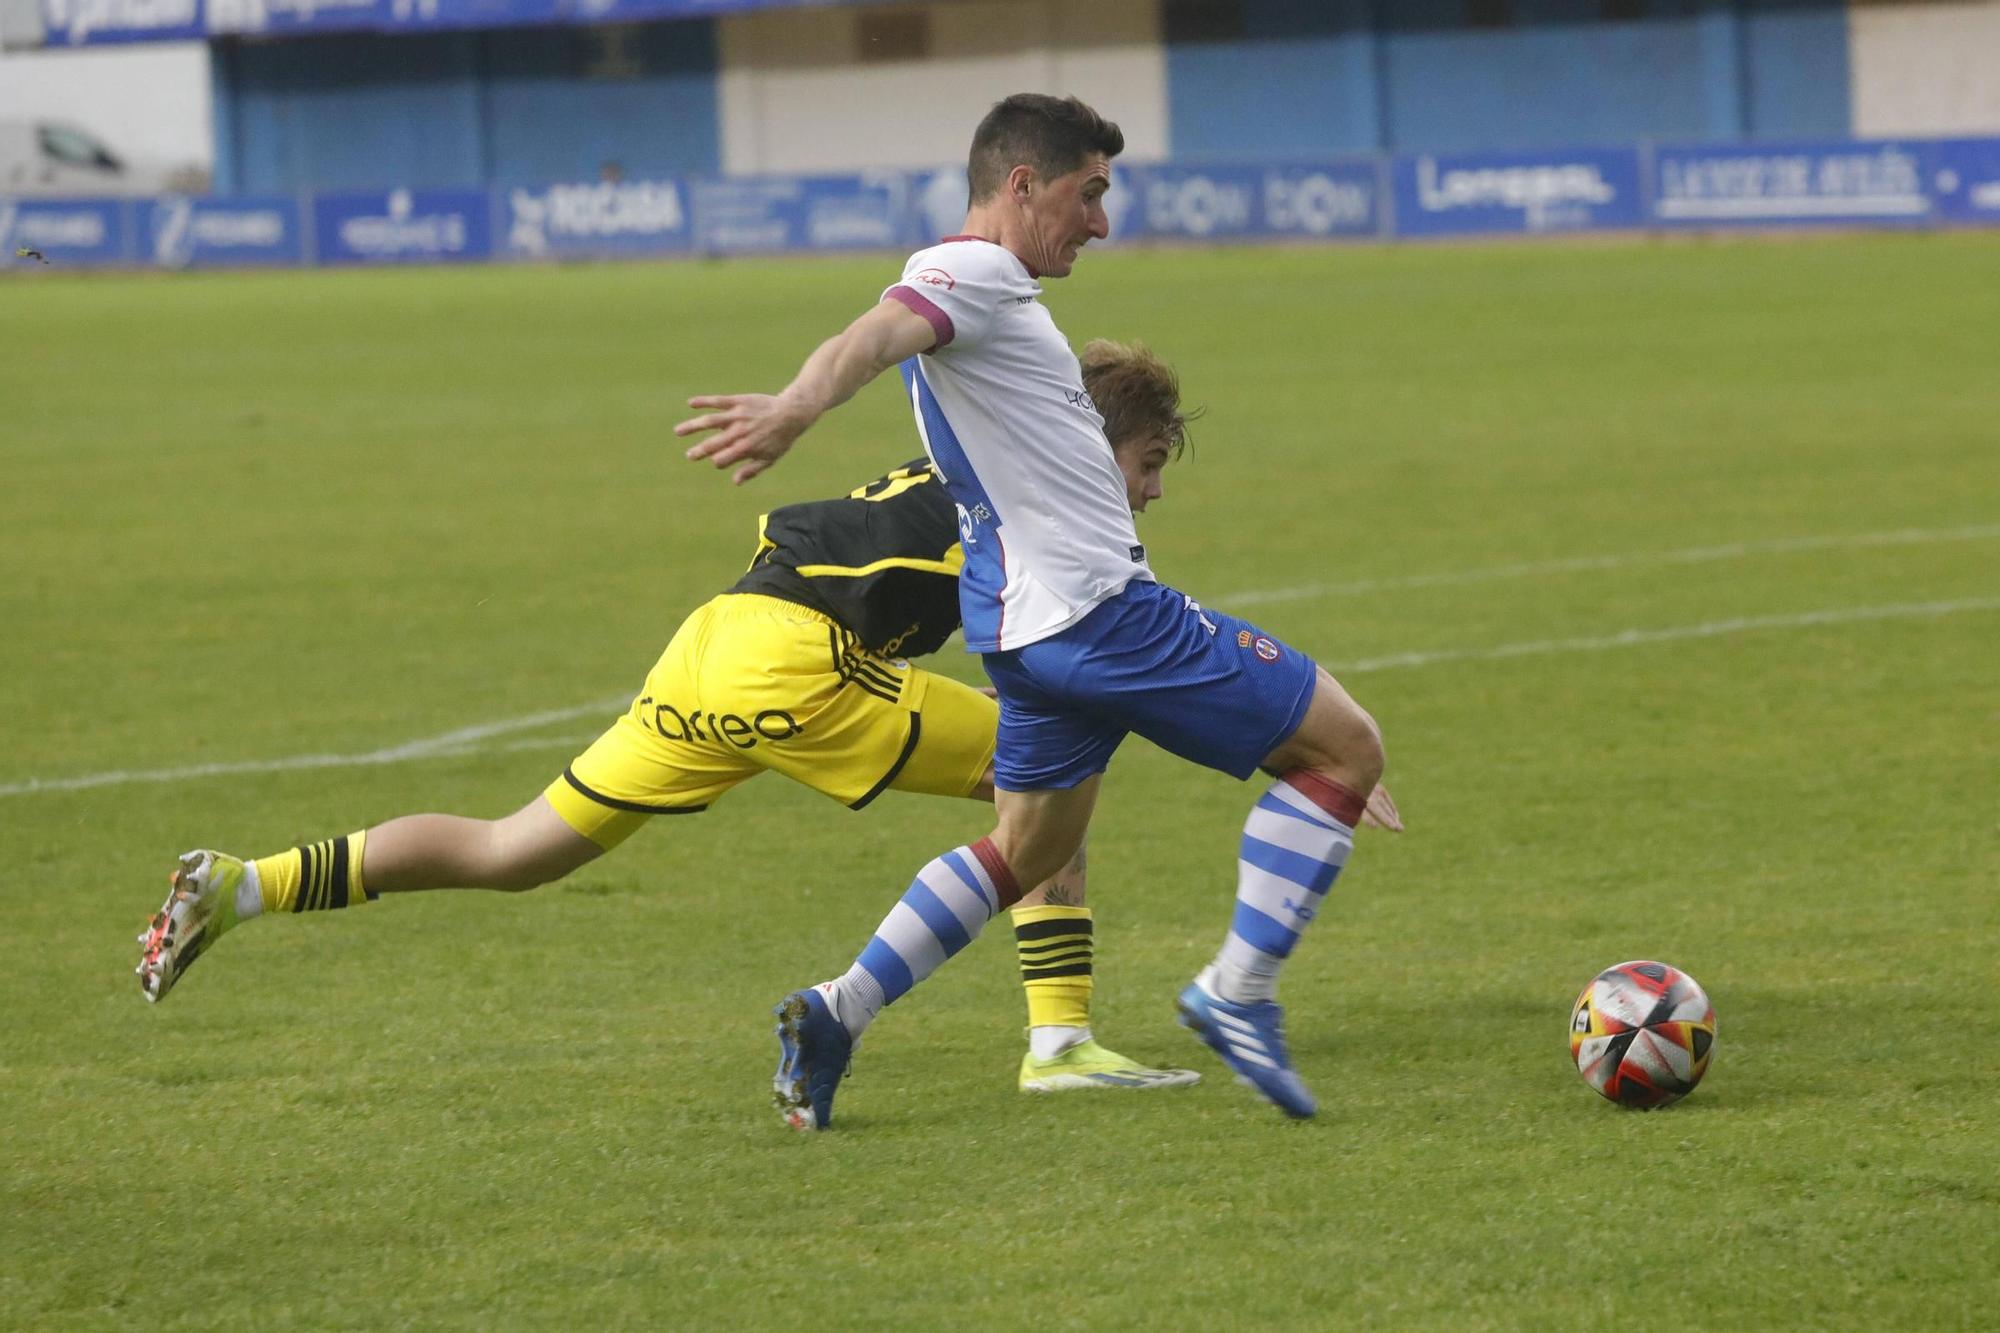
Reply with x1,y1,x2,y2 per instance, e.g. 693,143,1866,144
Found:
882,236,1152,652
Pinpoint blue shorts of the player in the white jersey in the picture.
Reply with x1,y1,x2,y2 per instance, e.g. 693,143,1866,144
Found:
984,582,1318,791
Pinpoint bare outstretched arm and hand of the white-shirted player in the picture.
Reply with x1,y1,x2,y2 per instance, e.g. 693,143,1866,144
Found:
674,300,938,486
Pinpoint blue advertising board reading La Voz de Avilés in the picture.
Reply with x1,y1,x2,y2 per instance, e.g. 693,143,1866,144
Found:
1652,142,1932,226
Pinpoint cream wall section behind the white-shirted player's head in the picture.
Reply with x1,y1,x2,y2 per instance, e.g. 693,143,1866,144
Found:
718,0,1168,174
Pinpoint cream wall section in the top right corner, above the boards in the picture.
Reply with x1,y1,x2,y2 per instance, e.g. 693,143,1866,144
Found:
1848,0,2000,136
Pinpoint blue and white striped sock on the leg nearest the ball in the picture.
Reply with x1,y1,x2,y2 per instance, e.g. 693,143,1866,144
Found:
1212,769,1364,1005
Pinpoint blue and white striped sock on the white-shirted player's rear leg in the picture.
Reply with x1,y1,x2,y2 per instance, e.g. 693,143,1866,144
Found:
820,839,1020,1037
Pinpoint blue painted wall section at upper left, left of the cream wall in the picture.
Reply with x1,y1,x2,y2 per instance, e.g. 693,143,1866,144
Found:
214,20,720,194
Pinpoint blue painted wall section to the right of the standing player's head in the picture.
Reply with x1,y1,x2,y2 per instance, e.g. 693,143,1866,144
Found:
1164,0,1850,158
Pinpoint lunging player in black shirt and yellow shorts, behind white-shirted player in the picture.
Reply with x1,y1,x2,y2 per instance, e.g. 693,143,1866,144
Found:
138,342,1200,1091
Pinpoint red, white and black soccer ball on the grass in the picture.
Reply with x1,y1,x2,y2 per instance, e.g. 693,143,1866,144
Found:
1570,961,1716,1111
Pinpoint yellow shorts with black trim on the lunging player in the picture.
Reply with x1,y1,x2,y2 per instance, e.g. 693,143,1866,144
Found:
544,592,1000,849
